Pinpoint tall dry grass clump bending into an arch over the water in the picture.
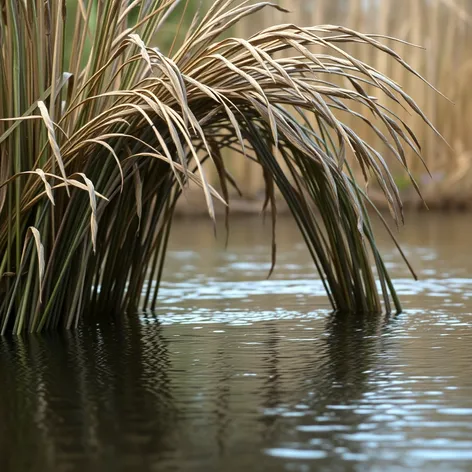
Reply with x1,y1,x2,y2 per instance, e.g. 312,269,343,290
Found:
0,0,436,333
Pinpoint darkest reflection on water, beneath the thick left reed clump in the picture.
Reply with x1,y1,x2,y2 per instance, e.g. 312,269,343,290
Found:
0,317,179,472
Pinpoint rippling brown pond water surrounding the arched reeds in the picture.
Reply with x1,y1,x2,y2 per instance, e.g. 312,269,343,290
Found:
0,215,472,472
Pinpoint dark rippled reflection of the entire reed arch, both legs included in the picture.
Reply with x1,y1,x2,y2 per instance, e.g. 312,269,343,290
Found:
0,315,388,471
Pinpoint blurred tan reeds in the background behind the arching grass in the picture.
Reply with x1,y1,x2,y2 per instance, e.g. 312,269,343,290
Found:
215,0,472,208
